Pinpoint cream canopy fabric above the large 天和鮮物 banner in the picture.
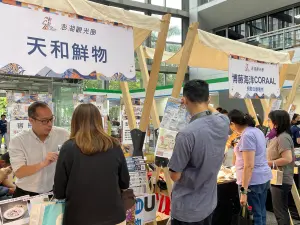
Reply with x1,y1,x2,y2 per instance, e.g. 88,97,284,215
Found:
20,0,161,49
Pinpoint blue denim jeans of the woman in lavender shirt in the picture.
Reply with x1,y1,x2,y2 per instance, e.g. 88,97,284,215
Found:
248,182,270,225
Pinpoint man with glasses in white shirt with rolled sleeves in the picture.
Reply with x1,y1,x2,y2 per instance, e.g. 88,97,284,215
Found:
9,102,69,198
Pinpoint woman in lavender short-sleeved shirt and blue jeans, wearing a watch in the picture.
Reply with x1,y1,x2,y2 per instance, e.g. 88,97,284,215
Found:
228,110,272,225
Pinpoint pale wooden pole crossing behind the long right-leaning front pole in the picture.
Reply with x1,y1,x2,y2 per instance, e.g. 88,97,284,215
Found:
136,46,160,129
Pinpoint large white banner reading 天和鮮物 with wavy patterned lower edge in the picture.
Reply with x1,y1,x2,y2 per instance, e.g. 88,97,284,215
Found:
0,1,135,81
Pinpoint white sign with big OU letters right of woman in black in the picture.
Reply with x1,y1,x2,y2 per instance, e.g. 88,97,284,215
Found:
135,194,157,225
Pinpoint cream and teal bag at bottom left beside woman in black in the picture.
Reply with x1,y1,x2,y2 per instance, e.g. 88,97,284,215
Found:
29,201,65,225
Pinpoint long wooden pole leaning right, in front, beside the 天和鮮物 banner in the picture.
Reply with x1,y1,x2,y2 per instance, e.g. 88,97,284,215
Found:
140,14,171,132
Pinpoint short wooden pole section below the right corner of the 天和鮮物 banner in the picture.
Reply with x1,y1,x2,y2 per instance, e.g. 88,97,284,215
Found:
120,82,136,130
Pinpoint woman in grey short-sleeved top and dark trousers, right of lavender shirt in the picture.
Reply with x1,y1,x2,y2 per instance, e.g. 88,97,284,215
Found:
267,110,295,225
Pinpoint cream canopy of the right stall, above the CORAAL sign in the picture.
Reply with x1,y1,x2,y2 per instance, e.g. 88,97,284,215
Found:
144,30,291,71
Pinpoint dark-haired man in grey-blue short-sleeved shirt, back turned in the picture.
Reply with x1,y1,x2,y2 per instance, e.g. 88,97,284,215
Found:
169,80,229,225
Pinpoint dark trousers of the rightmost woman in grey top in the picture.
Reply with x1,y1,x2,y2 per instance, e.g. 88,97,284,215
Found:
271,184,292,225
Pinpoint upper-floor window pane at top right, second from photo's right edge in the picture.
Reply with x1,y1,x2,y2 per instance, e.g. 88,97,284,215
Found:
269,9,293,31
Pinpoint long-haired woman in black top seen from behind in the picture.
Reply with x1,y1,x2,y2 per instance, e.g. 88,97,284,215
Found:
54,104,129,225
